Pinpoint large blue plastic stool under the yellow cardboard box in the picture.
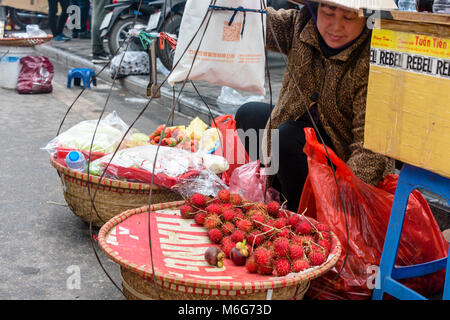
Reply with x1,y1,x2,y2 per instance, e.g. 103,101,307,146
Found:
372,164,450,300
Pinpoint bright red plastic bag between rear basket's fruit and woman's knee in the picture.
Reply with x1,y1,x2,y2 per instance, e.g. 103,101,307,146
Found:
211,114,250,185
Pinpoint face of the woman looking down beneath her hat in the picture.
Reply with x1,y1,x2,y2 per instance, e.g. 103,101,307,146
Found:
317,4,366,49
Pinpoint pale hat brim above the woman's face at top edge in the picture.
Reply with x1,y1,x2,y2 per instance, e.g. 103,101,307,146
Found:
289,0,398,11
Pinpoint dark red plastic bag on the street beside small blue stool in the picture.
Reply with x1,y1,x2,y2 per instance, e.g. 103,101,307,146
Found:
17,56,54,94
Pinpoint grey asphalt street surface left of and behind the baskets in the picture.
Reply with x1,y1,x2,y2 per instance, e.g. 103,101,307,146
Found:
0,61,191,300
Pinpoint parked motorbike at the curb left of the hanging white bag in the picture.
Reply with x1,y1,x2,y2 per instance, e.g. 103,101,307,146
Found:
100,0,186,70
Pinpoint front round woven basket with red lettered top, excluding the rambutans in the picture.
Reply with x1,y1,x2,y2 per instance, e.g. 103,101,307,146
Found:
98,201,341,300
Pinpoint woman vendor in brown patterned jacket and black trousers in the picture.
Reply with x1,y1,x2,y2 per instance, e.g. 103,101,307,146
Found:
235,0,395,212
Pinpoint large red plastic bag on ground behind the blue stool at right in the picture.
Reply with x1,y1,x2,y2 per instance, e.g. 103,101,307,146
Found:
298,128,448,300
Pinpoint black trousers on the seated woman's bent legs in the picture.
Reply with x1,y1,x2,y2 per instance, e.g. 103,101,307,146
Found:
235,102,332,212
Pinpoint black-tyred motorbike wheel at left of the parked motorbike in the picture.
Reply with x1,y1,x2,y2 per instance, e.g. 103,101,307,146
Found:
108,17,147,55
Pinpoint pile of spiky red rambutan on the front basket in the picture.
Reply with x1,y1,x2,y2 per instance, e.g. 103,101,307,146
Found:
180,189,331,277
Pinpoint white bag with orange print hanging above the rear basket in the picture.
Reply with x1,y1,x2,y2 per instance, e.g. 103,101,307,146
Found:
168,0,266,96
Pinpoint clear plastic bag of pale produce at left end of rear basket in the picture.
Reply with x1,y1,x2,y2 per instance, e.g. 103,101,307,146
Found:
43,111,133,160
